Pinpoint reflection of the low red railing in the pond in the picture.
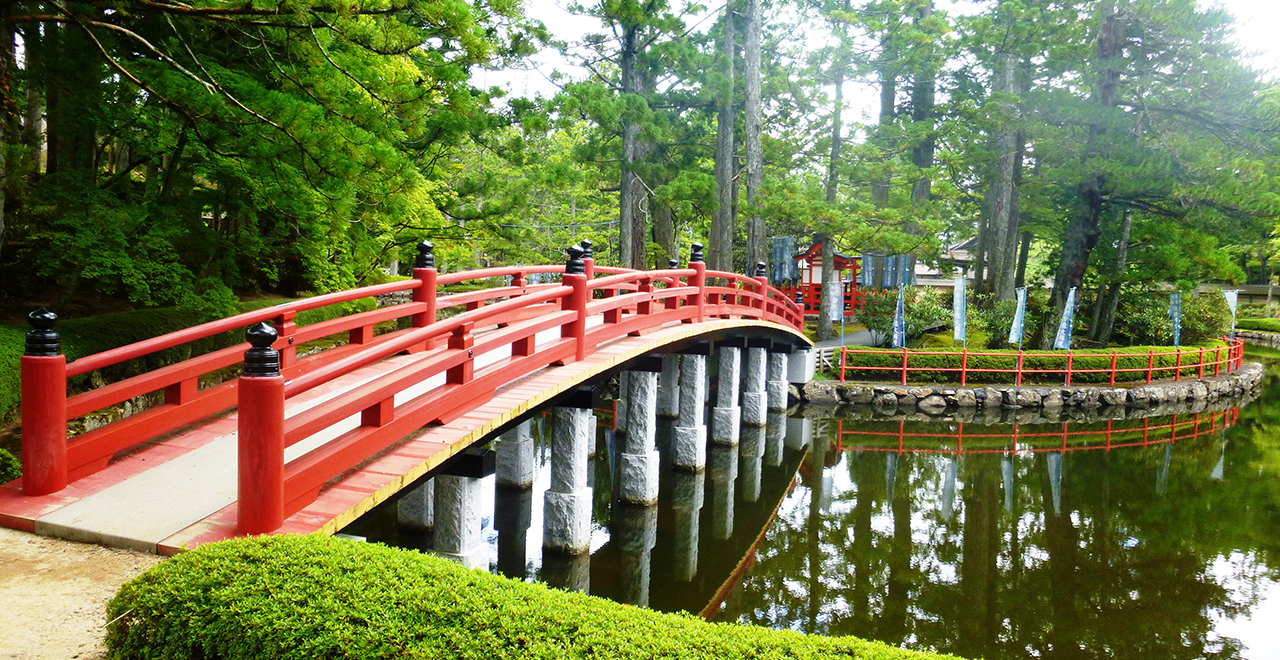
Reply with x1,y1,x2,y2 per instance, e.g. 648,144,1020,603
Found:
836,408,1240,454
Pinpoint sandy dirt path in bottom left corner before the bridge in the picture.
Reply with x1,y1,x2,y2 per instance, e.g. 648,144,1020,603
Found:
0,527,161,660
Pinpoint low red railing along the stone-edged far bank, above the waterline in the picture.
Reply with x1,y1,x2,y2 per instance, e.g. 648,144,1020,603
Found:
840,339,1244,385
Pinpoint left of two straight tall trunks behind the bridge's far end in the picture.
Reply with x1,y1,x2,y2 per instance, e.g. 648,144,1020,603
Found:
707,3,737,271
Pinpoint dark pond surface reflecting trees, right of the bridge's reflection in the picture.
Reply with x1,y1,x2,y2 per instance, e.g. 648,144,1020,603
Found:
718,358,1280,660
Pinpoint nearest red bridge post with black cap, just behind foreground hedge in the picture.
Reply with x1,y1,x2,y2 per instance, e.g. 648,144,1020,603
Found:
236,324,284,533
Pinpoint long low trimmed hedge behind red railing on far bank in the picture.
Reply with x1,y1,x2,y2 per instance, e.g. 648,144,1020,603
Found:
835,340,1228,385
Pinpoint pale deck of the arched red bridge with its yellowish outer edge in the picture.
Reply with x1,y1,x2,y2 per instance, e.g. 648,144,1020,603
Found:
0,320,781,555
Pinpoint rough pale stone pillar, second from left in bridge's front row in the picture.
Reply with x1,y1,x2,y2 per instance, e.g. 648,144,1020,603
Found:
543,408,595,555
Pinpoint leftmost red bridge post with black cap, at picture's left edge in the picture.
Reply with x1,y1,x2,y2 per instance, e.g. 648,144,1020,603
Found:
19,307,67,495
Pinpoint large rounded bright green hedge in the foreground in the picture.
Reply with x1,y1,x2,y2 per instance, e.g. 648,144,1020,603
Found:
106,536,948,660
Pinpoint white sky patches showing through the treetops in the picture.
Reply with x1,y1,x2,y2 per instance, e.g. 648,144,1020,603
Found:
475,0,1280,111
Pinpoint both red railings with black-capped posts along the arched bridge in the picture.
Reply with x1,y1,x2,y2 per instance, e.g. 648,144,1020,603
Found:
22,242,804,533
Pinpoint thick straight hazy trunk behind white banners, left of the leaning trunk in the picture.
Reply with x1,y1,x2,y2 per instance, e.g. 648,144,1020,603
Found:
987,52,1018,301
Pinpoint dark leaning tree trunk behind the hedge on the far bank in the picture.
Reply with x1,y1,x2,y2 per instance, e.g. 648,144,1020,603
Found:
1041,1,1125,349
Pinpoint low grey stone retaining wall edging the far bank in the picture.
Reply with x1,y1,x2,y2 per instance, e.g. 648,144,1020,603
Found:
791,362,1262,416
